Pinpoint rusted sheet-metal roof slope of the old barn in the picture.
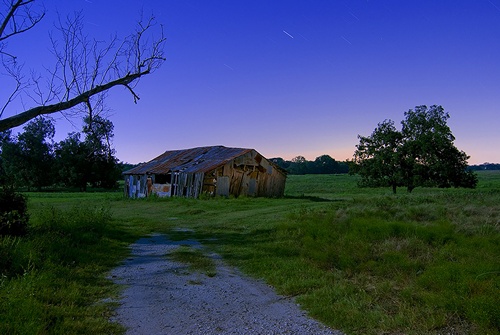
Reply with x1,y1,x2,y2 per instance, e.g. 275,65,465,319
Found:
123,146,253,175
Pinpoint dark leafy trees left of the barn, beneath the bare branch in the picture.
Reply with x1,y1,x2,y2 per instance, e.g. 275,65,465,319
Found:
0,115,121,191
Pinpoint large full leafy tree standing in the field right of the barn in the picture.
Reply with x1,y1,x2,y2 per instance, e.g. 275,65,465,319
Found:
351,105,477,193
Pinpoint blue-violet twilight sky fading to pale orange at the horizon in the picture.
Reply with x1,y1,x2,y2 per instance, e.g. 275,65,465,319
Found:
1,0,500,164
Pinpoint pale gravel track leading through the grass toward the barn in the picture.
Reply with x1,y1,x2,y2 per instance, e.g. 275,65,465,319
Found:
110,234,342,335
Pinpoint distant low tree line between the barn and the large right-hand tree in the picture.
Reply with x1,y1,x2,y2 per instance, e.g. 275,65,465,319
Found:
270,155,349,175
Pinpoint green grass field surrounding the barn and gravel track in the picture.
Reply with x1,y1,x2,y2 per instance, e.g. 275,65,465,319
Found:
0,171,500,334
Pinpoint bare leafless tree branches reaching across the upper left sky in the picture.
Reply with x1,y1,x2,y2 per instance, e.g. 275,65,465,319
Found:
0,0,165,131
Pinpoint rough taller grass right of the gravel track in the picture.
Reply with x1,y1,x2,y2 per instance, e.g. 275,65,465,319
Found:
275,195,500,334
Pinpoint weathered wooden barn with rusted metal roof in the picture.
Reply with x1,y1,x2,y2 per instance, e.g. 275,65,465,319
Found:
123,146,286,198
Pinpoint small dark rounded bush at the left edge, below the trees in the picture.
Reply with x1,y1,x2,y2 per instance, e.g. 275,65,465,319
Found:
0,187,29,236
